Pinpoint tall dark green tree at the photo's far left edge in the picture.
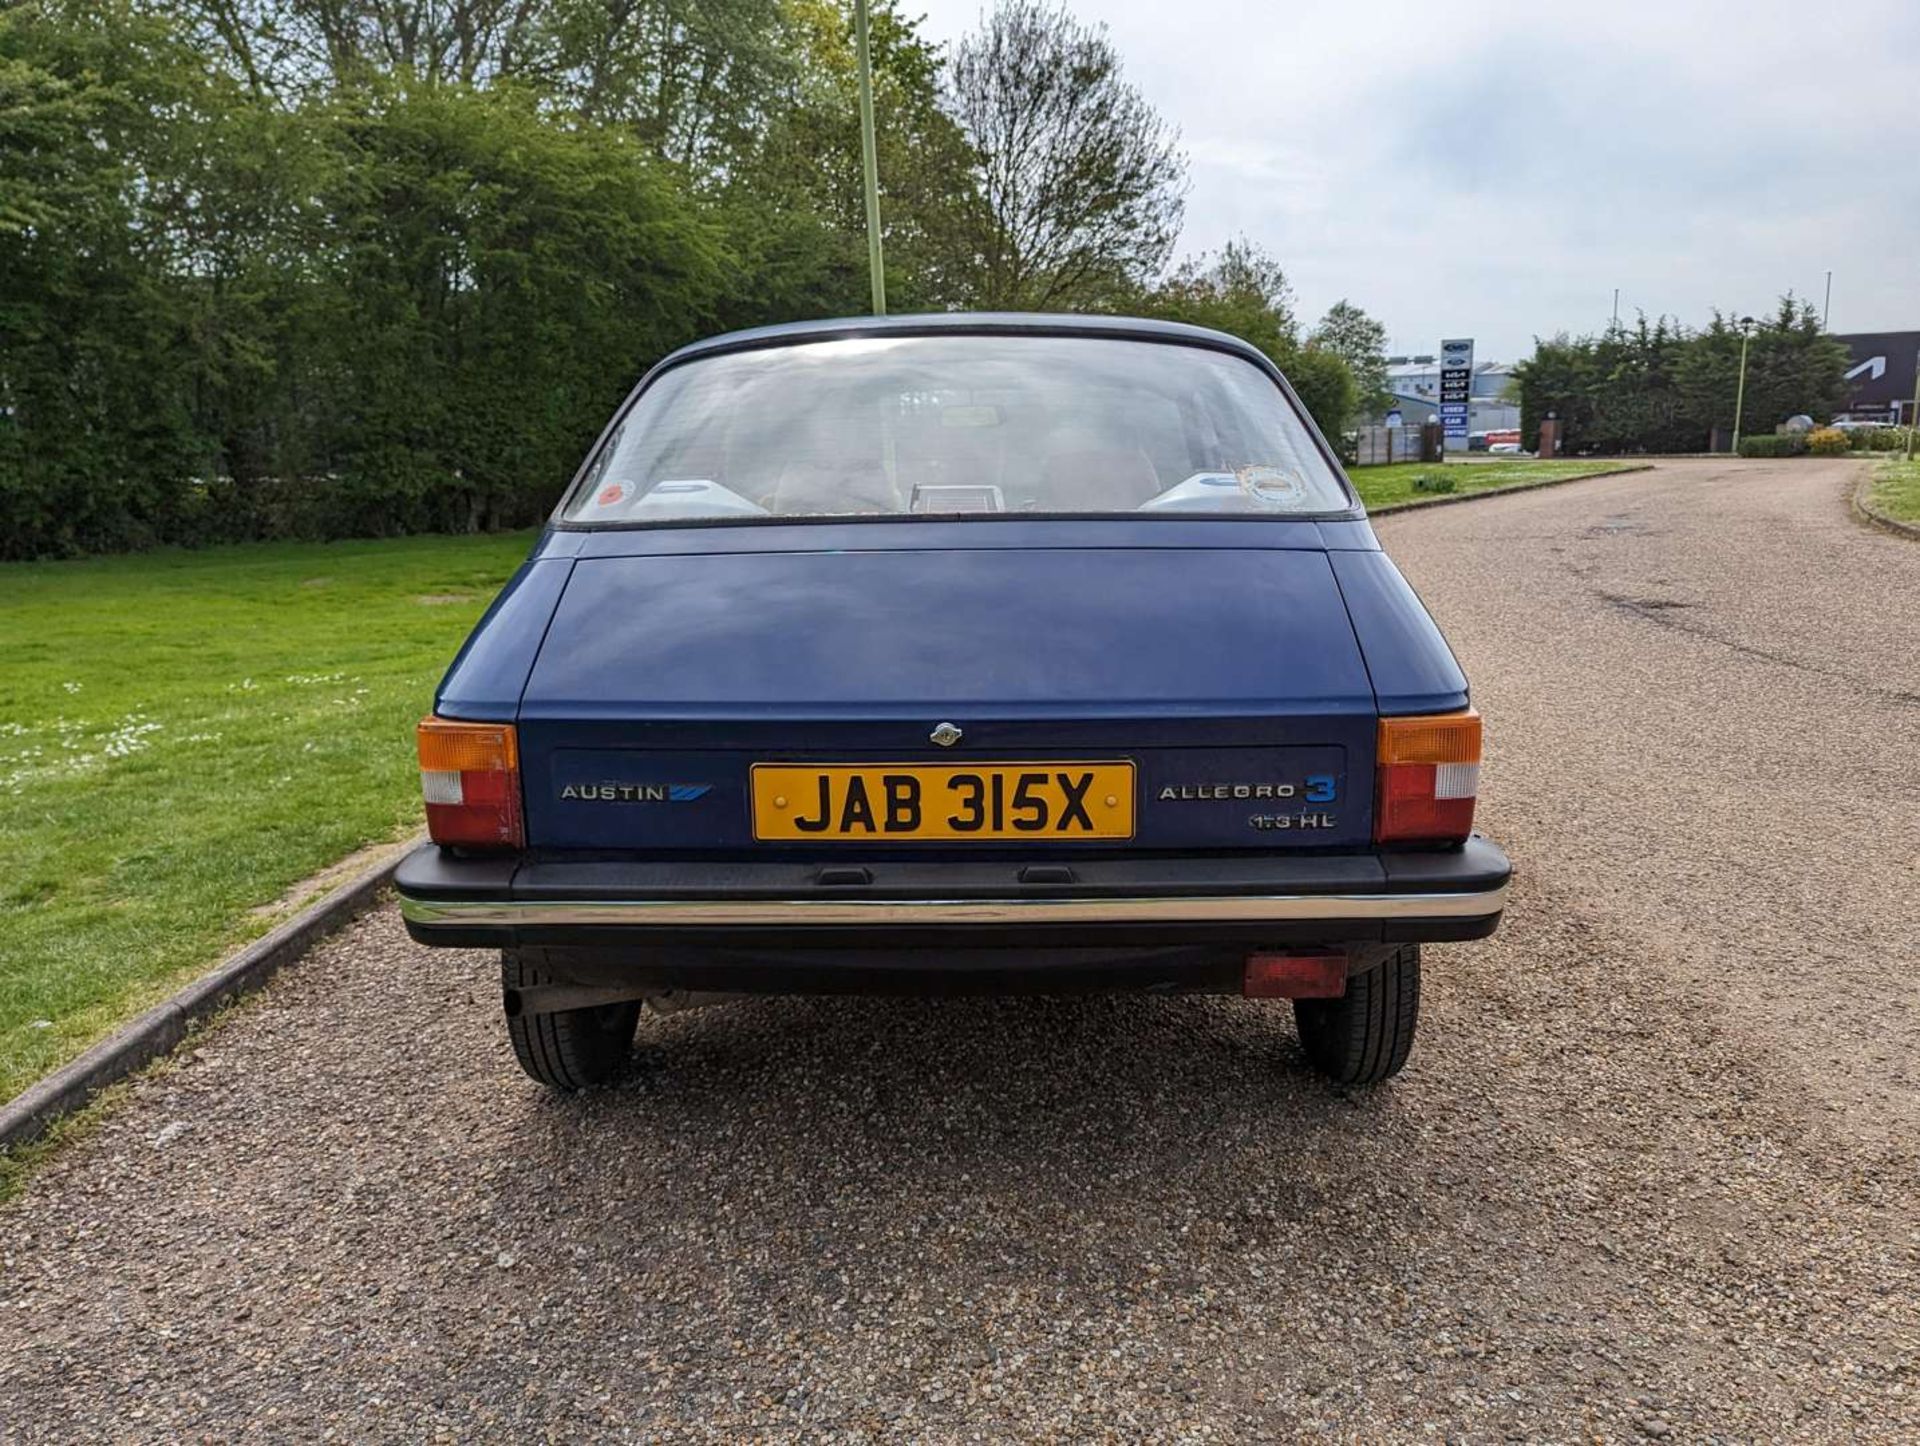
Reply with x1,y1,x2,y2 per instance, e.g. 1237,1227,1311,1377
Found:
0,0,223,557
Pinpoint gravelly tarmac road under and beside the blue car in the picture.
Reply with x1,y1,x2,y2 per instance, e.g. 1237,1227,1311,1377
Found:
0,461,1920,1442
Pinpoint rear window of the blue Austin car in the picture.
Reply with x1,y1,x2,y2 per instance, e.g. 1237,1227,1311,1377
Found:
561,334,1352,526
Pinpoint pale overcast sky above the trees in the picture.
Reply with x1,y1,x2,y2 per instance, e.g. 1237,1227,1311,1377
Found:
904,0,1920,359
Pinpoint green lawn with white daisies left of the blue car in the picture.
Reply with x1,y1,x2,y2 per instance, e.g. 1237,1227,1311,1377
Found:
0,534,532,1098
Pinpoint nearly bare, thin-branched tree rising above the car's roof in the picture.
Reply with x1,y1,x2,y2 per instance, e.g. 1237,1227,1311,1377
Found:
948,0,1187,309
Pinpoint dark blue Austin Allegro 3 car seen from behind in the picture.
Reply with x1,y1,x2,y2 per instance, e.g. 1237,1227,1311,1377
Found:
397,315,1509,1089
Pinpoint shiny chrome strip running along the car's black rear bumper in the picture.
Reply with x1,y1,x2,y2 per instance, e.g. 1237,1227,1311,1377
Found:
399,883,1507,928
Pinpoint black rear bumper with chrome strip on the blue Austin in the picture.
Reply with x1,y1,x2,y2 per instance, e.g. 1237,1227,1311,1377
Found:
396,837,1511,964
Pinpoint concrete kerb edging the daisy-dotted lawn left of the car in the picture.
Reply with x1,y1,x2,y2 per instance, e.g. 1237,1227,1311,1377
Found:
0,839,419,1150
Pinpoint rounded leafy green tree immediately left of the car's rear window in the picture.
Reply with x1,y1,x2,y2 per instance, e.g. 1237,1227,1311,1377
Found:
276,86,722,536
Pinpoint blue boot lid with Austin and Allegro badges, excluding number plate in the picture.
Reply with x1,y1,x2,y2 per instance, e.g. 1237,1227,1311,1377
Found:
520,547,1375,853
